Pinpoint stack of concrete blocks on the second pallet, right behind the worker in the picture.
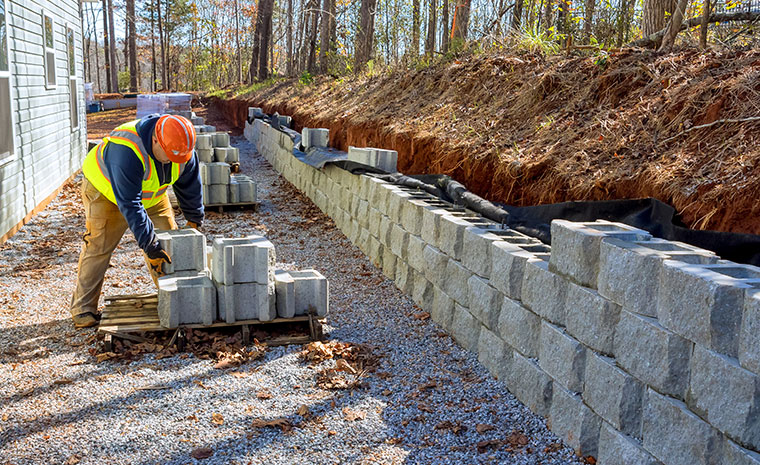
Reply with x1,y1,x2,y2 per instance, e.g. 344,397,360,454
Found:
195,132,256,205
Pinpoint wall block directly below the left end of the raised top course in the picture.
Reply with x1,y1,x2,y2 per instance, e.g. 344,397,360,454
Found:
520,260,569,326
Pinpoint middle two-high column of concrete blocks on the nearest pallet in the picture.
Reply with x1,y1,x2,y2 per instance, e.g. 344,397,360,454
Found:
211,235,276,323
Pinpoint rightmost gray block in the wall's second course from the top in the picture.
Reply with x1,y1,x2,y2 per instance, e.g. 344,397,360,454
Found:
686,344,760,450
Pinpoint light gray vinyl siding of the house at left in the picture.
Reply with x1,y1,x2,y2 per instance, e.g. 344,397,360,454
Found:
0,0,87,236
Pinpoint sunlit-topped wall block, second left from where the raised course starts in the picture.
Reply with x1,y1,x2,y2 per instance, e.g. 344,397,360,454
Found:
489,241,538,300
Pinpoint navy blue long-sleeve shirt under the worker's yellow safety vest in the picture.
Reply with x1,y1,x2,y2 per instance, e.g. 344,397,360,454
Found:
103,115,204,251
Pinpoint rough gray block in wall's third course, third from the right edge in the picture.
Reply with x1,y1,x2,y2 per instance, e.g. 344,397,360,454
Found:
583,351,645,439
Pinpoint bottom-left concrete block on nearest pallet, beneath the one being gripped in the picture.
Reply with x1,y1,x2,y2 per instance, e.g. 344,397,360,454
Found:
158,274,216,328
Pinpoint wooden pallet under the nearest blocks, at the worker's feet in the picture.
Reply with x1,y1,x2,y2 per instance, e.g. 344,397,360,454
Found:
98,294,324,352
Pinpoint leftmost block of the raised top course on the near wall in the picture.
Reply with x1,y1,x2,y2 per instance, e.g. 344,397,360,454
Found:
549,220,652,289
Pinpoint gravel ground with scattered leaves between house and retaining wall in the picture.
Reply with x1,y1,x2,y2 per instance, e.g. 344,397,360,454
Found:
0,137,583,465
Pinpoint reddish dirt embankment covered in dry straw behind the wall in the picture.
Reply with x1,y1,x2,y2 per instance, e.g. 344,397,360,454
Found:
208,50,760,234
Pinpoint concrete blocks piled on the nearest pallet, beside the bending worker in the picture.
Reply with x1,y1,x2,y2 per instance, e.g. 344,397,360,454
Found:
156,229,329,328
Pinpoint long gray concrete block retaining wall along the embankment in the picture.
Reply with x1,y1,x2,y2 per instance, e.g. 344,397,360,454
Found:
245,120,760,465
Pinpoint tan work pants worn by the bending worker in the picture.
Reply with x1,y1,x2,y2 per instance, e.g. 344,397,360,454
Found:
70,178,177,315
